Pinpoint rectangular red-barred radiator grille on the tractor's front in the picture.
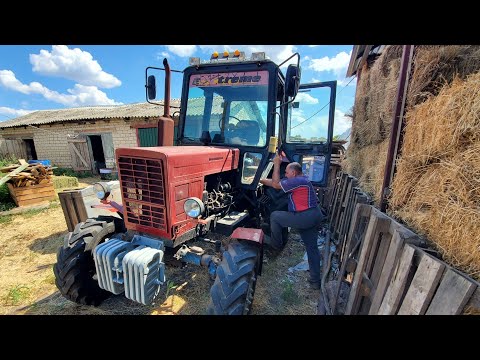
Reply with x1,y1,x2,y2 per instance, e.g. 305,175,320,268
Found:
118,156,166,231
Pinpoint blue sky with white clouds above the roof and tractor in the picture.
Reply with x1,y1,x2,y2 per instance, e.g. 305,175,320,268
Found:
0,45,356,134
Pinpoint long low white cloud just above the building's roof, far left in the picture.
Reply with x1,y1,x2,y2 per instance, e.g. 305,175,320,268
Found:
0,70,122,107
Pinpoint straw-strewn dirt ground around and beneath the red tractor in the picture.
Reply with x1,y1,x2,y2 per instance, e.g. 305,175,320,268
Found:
0,178,320,315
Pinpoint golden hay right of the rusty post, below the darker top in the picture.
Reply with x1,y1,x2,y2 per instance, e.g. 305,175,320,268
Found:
390,73,480,280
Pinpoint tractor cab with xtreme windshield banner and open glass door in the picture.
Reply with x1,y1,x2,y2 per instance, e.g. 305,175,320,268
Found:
146,51,336,190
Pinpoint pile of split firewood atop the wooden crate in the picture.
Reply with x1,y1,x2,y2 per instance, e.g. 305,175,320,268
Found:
0,159,53,188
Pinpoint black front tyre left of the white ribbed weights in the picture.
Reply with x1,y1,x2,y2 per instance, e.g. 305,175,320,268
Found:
53,216,124,306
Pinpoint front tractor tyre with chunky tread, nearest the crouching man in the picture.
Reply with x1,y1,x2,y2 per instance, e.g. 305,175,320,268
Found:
207,241,260,315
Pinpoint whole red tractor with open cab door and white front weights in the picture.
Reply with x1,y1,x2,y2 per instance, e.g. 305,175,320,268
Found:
54,51,336,314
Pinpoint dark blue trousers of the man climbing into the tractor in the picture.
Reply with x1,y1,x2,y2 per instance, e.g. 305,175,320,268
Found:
270,207,323,282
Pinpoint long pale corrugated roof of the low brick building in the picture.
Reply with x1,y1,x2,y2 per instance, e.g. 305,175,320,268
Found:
0,99,180,128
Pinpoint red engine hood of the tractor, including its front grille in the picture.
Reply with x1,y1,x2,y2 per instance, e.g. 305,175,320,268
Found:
115,146,240,245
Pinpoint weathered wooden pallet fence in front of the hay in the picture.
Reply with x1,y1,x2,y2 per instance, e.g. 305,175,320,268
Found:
328,174,480,315
